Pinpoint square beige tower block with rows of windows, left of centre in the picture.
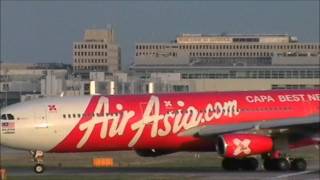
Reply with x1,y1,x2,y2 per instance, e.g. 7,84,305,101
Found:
73,29,121,74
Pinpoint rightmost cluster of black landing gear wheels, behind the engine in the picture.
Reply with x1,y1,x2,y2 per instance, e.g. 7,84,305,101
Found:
262,153,307,171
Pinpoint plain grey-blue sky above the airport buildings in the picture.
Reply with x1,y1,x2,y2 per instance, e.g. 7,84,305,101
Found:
1,0,320,68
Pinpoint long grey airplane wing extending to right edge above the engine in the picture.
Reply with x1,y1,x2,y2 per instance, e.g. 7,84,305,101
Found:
178,115,320,137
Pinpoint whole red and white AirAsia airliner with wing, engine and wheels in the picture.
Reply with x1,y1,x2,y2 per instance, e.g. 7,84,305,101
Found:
1,90,320,173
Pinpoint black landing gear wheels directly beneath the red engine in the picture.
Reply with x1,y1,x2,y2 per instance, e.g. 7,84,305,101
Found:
222,157,259,171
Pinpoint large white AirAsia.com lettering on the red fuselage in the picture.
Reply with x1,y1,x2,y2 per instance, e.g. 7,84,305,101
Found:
77,96,239,148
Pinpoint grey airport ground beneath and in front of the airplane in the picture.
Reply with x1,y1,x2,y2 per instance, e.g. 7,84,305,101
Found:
1,147,320,180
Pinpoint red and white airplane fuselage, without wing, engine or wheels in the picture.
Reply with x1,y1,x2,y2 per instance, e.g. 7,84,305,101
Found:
1,90,320,152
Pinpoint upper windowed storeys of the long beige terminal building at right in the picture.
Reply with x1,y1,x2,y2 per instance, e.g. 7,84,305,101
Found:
135,34,320,60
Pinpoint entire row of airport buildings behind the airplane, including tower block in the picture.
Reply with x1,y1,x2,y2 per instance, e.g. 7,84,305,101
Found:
0,33,320,106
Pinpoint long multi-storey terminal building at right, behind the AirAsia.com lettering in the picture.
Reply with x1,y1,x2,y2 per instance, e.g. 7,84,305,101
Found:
130,34,320,91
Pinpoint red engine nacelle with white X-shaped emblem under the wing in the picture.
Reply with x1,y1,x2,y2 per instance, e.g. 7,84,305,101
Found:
216,134,273,158
